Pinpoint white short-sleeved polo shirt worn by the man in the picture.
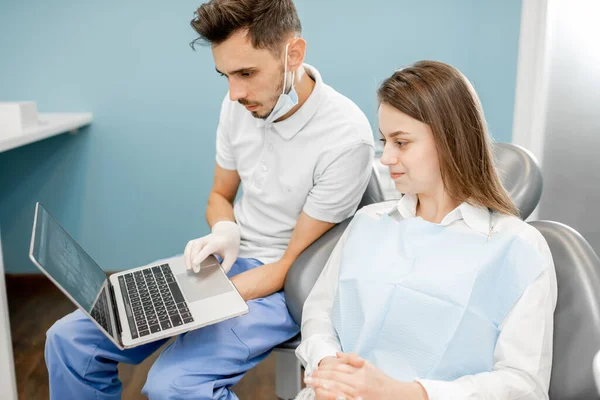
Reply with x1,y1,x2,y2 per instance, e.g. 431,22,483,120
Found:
217,64,374,264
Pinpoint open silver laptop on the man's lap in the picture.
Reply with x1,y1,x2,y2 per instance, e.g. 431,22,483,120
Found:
29,203,248,349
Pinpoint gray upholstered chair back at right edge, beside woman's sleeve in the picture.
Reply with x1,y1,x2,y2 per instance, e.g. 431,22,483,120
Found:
530,221,600,400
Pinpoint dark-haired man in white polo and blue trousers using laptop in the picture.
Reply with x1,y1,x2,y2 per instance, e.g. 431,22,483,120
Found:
45,0,374,400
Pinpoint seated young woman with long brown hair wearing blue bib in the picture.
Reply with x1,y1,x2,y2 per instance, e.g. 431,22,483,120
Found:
296,61,557,400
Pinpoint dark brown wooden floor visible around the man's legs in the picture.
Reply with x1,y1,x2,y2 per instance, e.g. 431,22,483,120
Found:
6,275,277,400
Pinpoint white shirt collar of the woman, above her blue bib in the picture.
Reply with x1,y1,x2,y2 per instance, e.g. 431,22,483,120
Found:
396,194,490,235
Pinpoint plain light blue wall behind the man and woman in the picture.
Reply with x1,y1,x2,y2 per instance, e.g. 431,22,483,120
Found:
0,0,521,273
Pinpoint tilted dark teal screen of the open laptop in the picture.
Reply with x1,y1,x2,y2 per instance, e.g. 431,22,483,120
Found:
30,203,107,320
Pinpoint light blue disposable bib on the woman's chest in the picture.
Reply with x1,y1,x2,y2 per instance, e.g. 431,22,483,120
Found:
331,214,544,381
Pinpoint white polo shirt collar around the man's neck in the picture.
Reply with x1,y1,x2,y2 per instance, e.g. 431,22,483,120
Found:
256,64,324,140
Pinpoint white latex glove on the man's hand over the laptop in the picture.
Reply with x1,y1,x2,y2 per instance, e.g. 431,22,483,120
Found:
183,221,240,273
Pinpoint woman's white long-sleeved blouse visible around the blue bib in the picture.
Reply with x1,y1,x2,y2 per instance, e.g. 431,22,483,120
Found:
296,195,557,400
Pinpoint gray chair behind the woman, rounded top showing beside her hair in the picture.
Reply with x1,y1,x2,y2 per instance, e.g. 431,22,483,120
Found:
274,143,548,400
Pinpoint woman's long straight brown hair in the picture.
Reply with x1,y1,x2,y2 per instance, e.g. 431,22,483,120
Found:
377,61,519,216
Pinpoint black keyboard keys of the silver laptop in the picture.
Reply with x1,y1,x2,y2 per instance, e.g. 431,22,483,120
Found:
119,264,194,339
